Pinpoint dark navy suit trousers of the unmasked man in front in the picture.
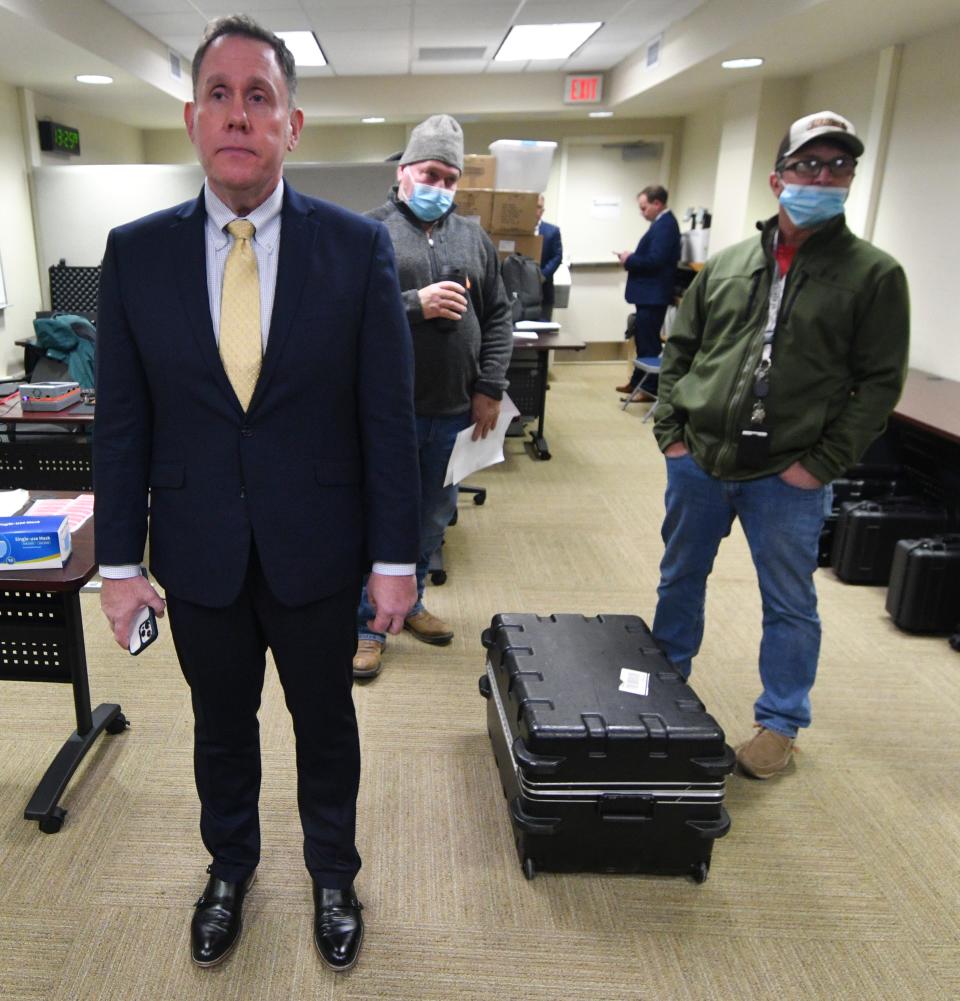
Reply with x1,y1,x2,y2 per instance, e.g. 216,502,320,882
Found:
166,545,360,889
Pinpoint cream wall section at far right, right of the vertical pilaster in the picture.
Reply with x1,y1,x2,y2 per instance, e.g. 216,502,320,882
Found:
874,25,960,379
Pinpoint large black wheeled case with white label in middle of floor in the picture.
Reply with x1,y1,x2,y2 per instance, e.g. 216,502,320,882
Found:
479,615,735,882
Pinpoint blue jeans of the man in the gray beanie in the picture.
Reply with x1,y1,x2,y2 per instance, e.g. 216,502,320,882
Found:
356,410,471,644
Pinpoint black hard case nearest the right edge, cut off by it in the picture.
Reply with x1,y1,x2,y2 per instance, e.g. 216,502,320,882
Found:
887,536,960,633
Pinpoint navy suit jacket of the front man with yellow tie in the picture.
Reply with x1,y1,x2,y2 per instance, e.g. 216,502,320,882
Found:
94,184,419,608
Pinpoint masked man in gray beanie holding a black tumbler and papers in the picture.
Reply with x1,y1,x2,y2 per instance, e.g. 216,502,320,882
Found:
353,115,514,679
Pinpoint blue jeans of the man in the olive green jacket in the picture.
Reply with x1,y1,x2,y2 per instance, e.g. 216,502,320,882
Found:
654,454,827,737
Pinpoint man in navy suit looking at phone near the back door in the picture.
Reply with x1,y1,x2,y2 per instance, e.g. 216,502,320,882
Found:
617,184,680,399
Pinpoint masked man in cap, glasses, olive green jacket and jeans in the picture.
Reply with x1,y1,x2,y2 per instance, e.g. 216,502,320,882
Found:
653,111,910,779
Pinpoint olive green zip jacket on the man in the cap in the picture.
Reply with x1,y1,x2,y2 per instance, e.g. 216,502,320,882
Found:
654,216,910,482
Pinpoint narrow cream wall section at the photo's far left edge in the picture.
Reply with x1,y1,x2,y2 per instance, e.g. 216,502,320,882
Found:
0,83,41,373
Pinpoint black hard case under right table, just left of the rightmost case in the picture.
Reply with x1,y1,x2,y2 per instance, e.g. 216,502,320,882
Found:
830,497,947,584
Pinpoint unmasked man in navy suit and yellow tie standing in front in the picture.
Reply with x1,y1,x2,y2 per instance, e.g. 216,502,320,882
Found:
94,15,418,970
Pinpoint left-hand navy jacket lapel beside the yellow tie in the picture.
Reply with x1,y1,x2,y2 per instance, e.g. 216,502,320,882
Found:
172,191,239,406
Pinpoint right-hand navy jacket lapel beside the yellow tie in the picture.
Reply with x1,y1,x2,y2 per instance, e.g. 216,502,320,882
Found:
250,181,314,409
